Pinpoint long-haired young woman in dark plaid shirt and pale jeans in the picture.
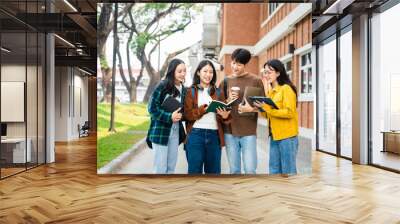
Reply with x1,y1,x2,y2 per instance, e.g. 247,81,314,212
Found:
147,59,186,174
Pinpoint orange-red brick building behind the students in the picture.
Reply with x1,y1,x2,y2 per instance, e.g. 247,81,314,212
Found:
218,3,315,148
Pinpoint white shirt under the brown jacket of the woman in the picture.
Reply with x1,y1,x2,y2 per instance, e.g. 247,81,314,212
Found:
193,88,218,130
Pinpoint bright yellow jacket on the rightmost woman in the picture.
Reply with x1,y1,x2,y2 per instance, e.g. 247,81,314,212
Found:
261,84,299,140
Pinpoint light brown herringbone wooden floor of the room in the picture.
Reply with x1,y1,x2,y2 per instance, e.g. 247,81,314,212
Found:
0,134,400,224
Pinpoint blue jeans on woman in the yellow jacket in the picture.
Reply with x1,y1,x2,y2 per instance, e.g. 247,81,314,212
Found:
269,136,299,174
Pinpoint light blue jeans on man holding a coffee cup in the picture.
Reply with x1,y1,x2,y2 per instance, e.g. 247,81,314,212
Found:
225,134,257,174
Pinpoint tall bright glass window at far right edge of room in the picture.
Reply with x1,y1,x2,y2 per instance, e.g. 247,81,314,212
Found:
370,4,400,171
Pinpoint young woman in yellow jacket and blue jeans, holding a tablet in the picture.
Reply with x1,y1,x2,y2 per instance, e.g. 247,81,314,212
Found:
254,59,299,175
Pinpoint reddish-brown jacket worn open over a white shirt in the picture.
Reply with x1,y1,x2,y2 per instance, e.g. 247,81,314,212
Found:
183,86,232,147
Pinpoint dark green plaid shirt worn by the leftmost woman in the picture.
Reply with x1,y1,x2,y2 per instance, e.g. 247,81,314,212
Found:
147,80,186,145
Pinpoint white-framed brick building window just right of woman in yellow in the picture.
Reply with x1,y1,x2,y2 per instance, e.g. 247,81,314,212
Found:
300,52,313,94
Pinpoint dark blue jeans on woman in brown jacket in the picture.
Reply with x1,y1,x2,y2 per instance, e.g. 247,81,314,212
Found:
186,128,221,174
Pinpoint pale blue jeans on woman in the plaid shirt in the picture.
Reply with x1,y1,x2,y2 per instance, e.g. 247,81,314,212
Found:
153,122,179,174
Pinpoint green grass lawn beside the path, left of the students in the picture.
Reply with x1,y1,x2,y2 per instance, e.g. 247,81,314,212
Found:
97,103,150,168
